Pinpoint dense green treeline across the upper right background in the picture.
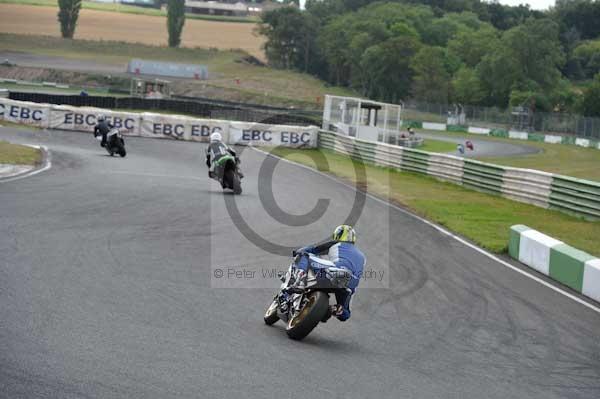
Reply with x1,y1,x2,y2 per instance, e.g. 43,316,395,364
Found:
259,0,600,116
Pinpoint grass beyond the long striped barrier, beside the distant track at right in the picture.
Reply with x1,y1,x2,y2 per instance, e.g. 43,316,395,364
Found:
420,131,600,181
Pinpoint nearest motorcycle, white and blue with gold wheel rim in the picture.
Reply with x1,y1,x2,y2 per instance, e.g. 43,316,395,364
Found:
263,254,352,340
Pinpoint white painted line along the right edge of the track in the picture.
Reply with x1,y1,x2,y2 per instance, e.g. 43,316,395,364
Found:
249,146,600,313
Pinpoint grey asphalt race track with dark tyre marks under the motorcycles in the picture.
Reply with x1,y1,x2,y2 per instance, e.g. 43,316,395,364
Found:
0,128,600,399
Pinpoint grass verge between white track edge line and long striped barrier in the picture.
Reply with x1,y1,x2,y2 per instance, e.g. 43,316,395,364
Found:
268,148,600,256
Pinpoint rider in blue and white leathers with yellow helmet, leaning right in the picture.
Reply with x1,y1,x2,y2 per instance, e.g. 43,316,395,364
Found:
295,225,366,321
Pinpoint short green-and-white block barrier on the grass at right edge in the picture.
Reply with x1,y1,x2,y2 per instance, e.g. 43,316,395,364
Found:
508,224,600,301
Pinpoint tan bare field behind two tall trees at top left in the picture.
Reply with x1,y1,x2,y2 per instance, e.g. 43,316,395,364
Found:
0,4,264,60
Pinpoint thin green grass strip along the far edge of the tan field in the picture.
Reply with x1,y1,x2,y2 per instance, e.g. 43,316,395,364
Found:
0,0,258,23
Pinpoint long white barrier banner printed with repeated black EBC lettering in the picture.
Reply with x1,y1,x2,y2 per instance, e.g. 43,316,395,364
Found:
0,98,318,147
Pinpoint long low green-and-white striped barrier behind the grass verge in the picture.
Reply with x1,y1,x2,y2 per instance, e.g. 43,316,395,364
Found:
319,131,600,220
